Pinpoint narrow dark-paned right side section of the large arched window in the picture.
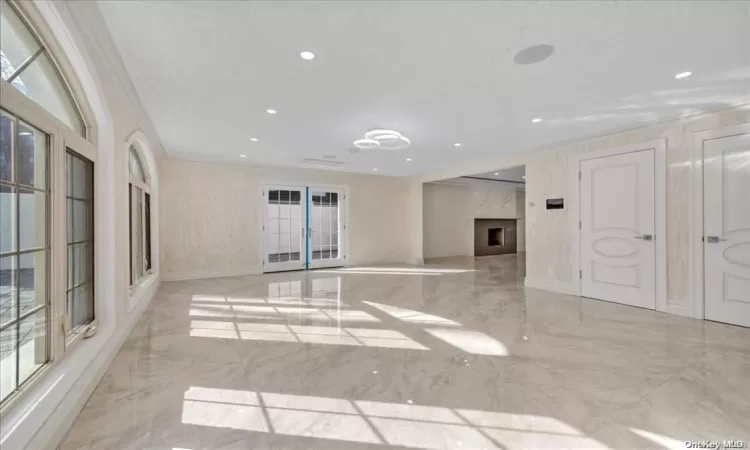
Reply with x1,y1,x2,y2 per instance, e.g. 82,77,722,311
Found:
65,149,94,339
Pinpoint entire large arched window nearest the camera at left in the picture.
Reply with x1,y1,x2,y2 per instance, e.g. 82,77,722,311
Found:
0,0,96,410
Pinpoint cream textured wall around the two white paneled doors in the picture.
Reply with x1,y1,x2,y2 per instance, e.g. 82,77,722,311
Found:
414,106,750,314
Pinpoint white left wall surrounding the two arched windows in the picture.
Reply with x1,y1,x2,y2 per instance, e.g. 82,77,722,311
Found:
0,1,164,449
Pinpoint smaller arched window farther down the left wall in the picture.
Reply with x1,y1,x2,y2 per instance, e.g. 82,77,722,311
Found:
128,145,151,286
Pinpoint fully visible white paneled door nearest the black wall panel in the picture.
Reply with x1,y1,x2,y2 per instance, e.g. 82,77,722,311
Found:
580,149,664,309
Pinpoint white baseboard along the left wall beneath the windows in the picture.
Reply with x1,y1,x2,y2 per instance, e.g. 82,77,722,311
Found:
2,279,160,449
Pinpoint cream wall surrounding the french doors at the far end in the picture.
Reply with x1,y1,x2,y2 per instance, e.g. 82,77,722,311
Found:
160,160,411,280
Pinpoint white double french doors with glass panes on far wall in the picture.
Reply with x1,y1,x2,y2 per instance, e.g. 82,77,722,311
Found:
263,185,346,272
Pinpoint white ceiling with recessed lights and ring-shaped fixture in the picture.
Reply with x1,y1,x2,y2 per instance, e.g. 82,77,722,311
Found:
99,1,750,175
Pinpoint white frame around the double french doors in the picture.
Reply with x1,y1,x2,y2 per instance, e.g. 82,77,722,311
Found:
258,181,349,273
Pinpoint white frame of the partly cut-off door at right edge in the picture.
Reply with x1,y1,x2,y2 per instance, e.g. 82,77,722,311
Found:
686,124,750,319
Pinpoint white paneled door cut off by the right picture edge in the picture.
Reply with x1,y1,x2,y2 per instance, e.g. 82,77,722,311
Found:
703,133,750,327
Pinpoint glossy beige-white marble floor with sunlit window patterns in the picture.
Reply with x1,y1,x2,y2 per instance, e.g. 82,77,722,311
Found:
61,255,750,450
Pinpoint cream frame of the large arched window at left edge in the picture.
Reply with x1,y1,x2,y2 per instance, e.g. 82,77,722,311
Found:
0,0,95,418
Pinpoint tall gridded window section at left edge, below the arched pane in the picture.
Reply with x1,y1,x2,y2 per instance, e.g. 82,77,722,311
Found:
0,111,50,400
